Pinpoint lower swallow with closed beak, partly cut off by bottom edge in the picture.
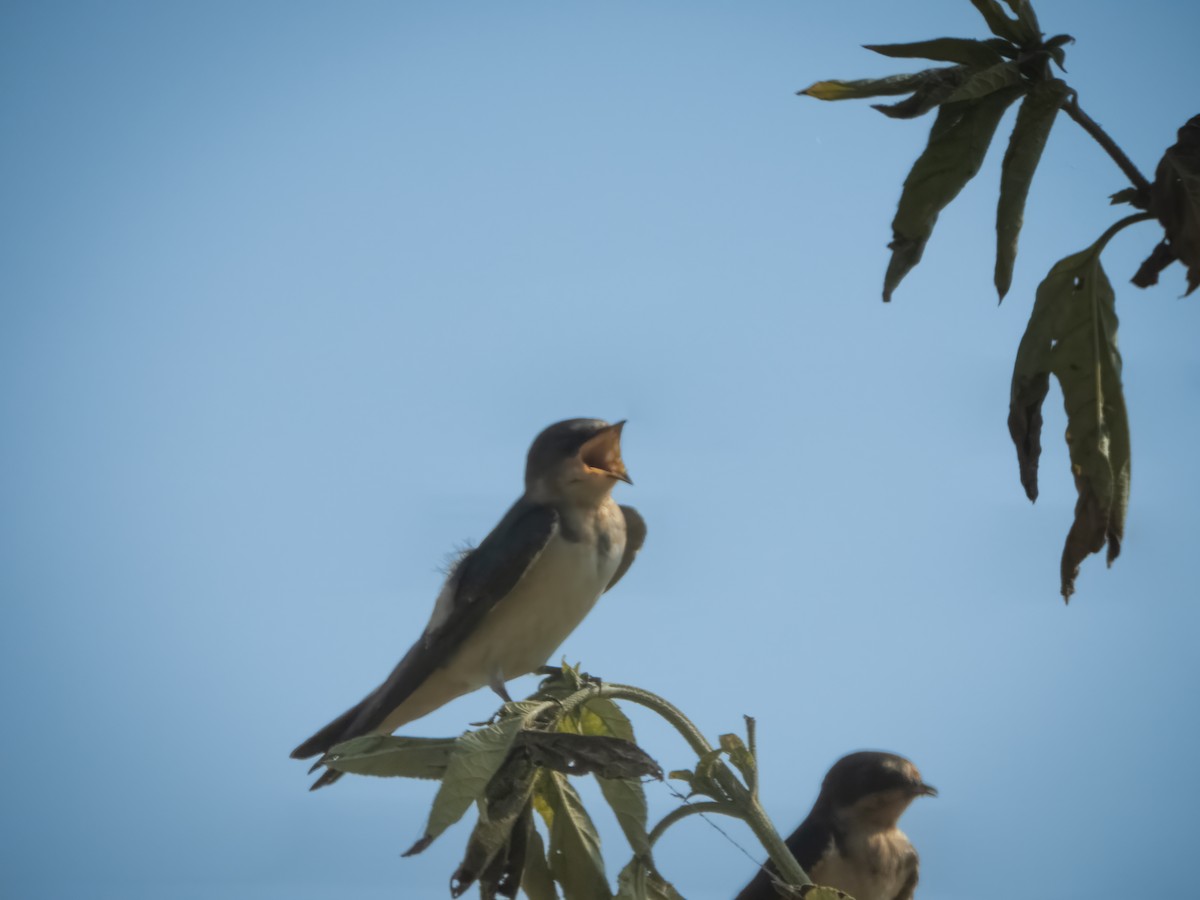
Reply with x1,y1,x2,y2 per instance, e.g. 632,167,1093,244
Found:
737,750,937,900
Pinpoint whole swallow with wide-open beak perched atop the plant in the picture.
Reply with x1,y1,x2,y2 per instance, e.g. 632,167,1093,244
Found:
292,419,646,791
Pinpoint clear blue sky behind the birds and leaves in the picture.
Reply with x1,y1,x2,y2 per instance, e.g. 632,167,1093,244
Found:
0,0,1200,900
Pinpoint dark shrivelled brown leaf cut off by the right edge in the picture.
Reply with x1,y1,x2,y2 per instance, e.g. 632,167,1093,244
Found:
1134,115,1200,294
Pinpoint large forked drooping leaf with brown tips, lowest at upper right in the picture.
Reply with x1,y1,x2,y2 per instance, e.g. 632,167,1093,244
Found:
1008,241,1130,600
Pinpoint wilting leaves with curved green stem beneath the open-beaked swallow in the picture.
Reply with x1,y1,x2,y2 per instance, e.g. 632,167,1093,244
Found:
326,666,809,900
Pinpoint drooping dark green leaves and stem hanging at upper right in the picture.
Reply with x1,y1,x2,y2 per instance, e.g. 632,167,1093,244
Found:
800,0,1200,599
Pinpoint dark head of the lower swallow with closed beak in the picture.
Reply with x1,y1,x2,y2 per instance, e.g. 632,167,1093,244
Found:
817,750,937,828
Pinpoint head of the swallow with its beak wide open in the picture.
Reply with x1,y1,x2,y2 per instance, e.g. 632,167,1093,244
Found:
526,419,632,500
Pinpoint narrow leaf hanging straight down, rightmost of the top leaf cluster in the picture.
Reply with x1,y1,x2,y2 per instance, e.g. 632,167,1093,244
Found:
995,78,1069,300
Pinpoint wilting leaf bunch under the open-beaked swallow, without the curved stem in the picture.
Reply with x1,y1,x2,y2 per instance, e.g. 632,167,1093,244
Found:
328,667,673,900
